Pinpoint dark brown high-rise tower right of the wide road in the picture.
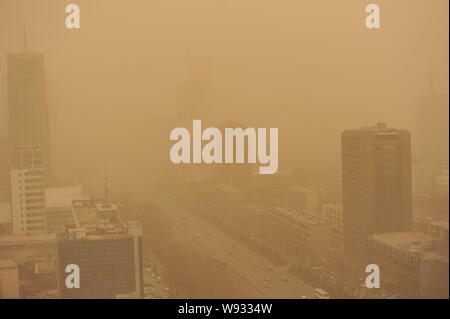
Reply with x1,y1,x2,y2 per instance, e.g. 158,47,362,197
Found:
342,123,412,262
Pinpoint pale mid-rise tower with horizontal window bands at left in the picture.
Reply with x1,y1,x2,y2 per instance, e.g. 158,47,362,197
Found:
10,146,47,234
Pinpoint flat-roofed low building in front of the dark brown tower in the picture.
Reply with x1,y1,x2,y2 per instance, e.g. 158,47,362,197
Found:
365,232,449,299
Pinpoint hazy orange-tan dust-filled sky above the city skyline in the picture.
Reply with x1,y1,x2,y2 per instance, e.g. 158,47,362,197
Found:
0,0,448,192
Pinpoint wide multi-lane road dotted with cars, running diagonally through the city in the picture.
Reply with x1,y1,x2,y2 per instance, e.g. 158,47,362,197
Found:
154,195,315,299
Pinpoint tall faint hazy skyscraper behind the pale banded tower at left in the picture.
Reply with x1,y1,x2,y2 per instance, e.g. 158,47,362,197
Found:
7,49,51,174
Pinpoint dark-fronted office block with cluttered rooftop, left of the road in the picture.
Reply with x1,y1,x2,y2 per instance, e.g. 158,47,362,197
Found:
56,200,143,298
